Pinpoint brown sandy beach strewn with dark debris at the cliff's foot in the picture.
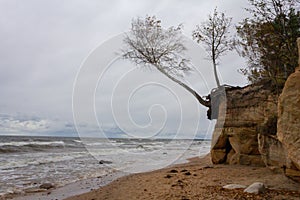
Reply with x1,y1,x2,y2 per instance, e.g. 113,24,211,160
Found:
68,156,300,200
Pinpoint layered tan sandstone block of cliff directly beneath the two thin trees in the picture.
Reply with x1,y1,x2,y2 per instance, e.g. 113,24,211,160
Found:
211,84,277,166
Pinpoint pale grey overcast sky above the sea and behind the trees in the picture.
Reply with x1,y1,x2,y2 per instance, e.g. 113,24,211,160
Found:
0,0,247,138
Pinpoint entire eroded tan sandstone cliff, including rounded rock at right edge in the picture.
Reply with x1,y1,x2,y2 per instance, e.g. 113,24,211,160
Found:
211,39,300,181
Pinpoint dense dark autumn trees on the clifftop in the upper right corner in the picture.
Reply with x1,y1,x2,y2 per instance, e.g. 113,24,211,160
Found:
235,0,300,87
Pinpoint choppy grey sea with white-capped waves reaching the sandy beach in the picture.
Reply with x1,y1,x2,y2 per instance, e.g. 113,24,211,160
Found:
0,136,210,197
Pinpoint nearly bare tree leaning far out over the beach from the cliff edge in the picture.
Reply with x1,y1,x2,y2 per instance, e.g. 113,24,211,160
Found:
123,16,210,107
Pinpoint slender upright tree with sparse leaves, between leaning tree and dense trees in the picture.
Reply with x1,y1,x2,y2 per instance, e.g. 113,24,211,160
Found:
193,8,232,87
